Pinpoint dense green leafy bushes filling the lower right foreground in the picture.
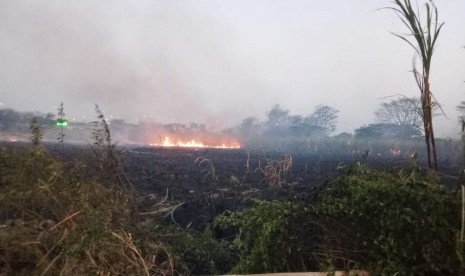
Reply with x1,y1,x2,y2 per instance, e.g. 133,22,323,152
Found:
217,164,463,275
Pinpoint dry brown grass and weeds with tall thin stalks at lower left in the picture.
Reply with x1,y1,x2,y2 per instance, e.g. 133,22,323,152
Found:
0,110,239,275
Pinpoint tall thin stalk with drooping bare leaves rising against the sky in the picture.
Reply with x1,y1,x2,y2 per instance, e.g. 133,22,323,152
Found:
390,0,444,171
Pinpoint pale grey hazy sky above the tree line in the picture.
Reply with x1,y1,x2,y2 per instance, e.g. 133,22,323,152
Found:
0,0,465,136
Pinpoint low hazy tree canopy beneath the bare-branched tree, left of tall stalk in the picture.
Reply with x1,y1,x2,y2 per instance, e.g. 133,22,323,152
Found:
355,123,422,139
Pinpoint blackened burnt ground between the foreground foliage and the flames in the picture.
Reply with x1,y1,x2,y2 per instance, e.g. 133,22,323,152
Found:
123,147,459,230
